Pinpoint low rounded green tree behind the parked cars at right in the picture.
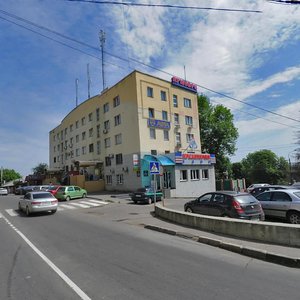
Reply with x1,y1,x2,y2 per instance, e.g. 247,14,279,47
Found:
241,150,289,185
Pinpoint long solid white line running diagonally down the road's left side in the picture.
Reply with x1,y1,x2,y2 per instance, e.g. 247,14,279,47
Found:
0,214,92,300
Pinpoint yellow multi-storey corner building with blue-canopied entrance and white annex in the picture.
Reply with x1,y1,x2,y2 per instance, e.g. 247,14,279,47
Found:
49,71,215,197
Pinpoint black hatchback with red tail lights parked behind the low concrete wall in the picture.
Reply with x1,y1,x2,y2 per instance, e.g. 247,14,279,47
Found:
184,191,265,220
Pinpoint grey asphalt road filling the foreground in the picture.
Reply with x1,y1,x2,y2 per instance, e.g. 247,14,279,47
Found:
0,196,300,300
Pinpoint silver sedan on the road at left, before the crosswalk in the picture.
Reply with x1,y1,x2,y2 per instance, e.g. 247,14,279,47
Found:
19,192,58,216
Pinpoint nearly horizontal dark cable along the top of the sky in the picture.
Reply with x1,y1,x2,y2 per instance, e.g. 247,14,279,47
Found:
66,0,262,13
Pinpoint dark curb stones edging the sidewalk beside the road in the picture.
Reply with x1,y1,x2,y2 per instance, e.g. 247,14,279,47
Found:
144,224,300,268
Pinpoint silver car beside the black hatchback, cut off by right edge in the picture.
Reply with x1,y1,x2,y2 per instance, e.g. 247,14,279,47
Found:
256,189,300,224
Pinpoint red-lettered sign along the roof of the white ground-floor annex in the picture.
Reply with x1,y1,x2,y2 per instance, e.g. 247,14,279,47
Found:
175,152,216,165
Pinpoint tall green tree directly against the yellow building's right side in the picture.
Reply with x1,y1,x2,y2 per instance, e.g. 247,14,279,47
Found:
198,95,239,178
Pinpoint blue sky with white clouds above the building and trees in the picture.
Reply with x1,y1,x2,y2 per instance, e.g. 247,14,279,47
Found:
0,0,300,176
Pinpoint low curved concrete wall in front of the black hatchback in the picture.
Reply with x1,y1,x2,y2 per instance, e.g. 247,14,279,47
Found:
155,203,300,247
